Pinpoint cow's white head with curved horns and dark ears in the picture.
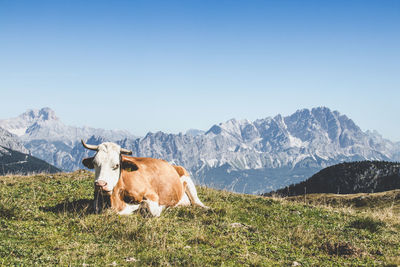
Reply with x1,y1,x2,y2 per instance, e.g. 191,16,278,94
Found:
82,140,132,195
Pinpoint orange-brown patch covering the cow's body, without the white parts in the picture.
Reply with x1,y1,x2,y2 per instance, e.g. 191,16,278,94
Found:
121,157,184,206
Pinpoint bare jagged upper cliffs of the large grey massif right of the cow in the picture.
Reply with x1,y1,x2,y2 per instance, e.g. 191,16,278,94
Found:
205,107,378,151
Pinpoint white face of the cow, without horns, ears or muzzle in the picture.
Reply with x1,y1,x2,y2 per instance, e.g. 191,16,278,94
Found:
93,142,121,192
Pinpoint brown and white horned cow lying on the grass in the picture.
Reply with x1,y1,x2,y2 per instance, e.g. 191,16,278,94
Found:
82,140,207,217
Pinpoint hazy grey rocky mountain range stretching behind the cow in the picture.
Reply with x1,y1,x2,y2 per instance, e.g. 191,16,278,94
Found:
0,107,400,193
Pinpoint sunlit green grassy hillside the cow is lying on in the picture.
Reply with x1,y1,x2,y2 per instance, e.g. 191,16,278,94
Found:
0,171,400,266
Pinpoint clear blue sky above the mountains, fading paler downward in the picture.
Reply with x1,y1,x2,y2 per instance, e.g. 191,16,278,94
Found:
0,0,400,141
